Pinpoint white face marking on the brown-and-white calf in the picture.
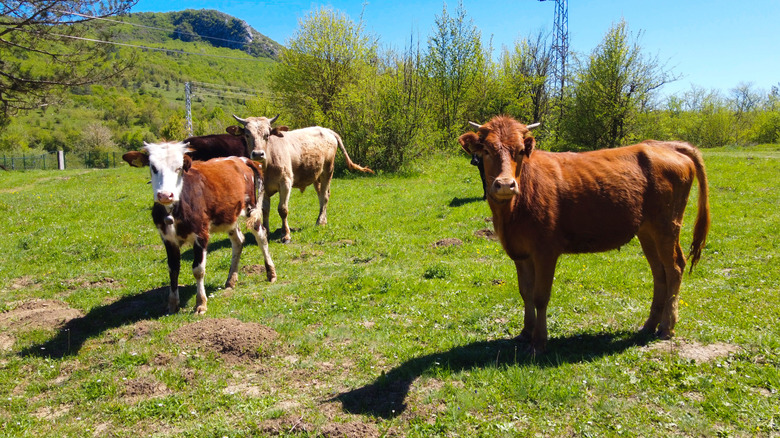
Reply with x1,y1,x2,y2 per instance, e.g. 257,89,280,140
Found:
144,143,187,205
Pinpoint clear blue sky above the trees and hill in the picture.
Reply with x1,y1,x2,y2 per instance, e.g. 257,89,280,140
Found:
132,0,780,94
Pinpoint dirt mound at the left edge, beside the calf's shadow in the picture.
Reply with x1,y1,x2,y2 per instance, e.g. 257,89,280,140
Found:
0,300,84,331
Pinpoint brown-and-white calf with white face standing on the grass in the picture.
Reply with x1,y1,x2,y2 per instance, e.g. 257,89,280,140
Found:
122,143,276,314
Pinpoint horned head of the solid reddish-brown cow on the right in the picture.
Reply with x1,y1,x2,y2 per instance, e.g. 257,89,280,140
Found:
458,116,539,202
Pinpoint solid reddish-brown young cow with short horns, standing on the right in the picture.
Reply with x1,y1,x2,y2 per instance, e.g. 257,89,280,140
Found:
458,116,710,352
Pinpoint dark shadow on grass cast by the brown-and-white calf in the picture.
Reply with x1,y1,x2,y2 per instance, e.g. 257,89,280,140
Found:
19,285,198,359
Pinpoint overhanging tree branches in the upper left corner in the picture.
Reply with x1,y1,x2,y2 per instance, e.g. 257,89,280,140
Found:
0,0,137,127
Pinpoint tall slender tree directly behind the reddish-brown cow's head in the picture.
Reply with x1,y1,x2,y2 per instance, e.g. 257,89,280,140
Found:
426,2,487,148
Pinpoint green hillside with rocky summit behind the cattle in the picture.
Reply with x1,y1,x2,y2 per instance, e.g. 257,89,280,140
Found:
0,10,282,153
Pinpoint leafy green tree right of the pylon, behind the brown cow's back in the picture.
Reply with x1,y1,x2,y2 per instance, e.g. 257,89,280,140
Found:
562,21,677,148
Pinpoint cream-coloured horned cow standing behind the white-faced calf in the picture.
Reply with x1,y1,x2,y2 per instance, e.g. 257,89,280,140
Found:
233,115,374,243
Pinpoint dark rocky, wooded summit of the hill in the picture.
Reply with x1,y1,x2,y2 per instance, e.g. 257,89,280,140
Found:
124,9,282,59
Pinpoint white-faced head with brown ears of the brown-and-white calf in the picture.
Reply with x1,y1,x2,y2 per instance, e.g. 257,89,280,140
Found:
122,142,192,206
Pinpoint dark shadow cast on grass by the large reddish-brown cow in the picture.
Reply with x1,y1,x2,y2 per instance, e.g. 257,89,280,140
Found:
329,331,653,419
